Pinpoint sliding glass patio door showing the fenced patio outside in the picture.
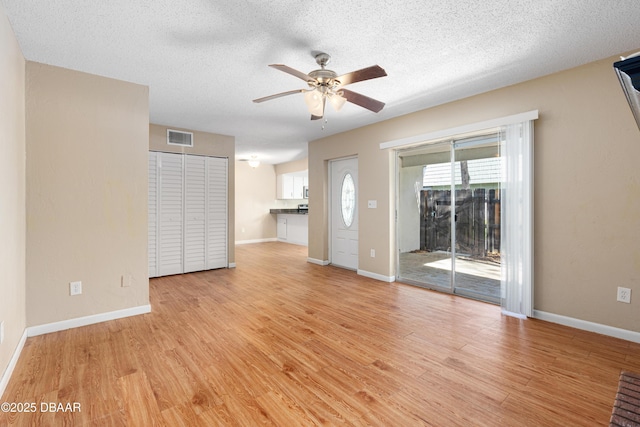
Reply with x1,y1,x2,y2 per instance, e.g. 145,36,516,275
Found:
398,132,502,303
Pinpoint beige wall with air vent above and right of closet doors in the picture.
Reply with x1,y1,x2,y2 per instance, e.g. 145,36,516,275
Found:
149,124,236,264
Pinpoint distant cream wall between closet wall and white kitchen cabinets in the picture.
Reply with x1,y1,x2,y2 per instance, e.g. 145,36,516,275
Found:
236,161,279,242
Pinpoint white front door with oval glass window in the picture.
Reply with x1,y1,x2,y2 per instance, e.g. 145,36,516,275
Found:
330,157,358,270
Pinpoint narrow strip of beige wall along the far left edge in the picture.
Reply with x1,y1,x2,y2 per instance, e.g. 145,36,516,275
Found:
0,6,26,394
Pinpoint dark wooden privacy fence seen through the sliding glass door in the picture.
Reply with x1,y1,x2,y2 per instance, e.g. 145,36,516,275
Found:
420,188,500,256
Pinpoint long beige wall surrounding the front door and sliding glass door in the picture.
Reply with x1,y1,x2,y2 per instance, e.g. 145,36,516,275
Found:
309,51,640,331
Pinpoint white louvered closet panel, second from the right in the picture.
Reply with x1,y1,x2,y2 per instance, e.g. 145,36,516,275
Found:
184,155,207,273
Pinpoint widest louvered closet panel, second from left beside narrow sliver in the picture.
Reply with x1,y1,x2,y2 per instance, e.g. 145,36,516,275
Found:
158,153,184,276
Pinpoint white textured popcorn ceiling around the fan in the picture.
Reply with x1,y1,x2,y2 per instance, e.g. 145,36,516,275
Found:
0,0,640,163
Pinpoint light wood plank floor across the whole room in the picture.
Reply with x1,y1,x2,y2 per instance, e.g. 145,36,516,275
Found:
0,243,640,426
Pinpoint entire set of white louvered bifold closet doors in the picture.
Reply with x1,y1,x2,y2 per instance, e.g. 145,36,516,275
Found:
148,152,228,277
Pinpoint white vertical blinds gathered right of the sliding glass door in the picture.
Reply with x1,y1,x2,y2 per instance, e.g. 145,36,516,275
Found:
500,121,533,318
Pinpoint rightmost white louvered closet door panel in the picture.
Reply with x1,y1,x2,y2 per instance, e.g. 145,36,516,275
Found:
207,157,228,269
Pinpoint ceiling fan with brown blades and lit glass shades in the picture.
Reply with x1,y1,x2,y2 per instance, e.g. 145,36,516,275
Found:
253,53,387,120
